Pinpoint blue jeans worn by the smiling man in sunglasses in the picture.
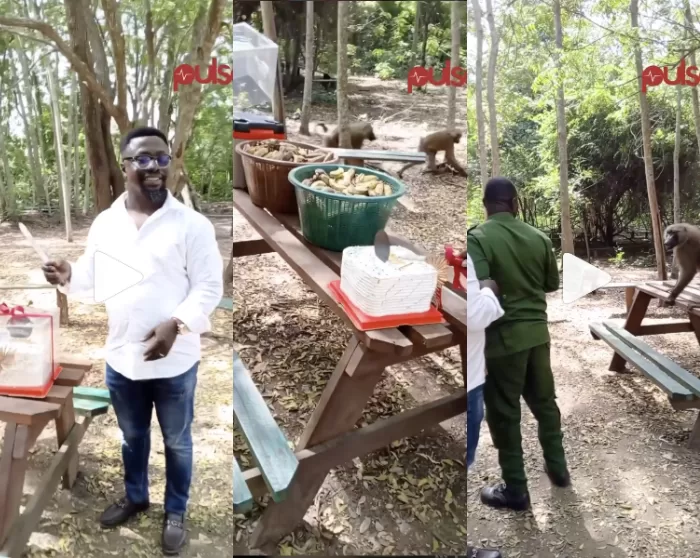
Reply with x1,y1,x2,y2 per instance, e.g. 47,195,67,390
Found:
106,362,199,514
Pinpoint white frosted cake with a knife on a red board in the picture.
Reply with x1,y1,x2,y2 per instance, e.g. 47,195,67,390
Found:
340,246,438,317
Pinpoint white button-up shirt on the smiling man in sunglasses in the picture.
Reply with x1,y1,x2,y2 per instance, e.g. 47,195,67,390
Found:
60,193,223,380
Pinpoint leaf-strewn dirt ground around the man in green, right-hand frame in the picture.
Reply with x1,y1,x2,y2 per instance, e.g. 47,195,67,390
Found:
467,262,700,558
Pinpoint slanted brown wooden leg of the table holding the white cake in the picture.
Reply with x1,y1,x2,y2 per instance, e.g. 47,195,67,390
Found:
252,337,394,548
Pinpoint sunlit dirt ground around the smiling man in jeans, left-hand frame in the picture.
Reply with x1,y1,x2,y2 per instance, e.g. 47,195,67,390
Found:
0,204,233,558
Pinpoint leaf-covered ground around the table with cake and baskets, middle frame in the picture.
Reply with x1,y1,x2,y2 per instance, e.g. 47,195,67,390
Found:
234,79,467,556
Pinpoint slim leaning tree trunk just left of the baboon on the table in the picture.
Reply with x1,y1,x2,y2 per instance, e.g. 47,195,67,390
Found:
630,0,666,280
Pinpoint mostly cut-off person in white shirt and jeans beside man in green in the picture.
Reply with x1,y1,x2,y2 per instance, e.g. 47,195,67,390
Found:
462,251,503,558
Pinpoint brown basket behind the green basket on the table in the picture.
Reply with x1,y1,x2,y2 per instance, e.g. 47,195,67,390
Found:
236,140,338,213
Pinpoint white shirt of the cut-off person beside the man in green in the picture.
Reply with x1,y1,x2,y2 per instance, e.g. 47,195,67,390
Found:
467,254,504,392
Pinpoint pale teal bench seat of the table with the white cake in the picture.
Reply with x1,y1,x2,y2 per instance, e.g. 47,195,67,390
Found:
233,352,299,513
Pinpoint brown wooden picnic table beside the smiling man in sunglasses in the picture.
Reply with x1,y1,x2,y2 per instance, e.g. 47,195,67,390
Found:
0,356,109,558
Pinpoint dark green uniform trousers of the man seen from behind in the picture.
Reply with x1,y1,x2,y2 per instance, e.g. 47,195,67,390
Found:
484,343,567,490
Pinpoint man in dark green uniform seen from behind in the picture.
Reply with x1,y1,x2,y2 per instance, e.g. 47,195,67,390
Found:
467,178,571,511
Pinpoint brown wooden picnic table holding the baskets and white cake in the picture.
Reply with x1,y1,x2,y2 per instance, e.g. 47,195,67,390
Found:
233,191,467,548
